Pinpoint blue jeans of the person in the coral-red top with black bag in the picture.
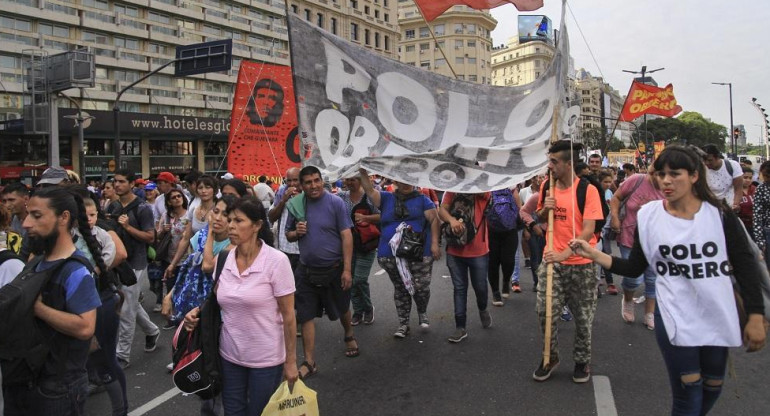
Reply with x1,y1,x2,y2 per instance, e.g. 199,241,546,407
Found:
446,254,489,328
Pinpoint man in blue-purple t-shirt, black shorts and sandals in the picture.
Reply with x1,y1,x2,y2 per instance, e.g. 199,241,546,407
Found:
286,166,359,378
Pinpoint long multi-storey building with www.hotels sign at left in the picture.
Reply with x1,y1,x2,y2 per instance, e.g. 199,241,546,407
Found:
0,0,294,181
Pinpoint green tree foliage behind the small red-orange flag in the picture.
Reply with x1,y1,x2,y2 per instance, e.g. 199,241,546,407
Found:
635,111,728,151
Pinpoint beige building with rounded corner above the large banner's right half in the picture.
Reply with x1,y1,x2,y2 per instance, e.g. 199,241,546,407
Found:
398,0,497,84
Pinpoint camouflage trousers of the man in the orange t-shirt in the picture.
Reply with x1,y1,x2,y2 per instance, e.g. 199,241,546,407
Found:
537,263,596,363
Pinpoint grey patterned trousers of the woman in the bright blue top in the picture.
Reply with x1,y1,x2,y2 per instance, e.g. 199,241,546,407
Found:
377,257,433,325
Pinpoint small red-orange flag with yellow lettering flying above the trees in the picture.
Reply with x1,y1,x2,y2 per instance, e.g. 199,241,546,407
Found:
620,81,682,121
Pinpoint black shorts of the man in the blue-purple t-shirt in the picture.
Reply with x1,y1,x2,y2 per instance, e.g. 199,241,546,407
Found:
294,264,350,324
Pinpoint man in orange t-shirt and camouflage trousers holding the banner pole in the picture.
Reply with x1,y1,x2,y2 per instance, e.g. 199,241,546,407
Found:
532,140,604,383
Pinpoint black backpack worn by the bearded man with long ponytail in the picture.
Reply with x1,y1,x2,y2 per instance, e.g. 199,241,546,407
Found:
0,256,93,386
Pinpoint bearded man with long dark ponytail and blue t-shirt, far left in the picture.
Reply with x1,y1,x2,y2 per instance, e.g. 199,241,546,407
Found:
3,188,101,416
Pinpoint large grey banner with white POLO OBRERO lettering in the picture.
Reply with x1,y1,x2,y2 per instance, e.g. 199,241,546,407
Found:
289,13,579,193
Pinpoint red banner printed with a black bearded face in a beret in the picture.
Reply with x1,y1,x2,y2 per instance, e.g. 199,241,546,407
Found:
227,61,300,184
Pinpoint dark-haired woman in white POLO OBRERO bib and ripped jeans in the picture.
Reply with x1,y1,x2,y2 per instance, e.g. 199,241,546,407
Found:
570,146,765,415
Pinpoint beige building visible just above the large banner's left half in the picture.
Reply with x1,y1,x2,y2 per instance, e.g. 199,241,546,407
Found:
289,0,399,59
